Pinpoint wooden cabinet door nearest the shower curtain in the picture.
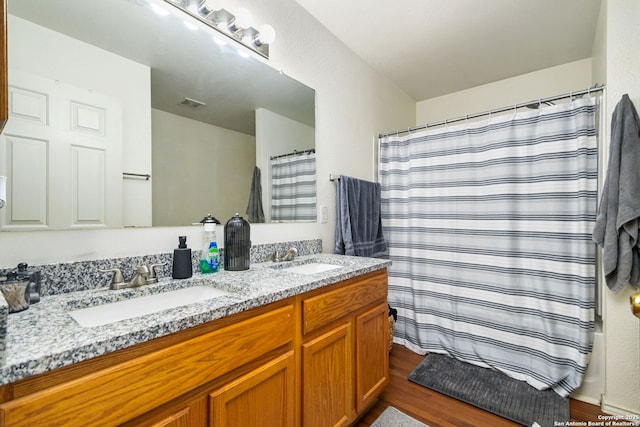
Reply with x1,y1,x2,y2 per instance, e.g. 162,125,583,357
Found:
356,303,389,413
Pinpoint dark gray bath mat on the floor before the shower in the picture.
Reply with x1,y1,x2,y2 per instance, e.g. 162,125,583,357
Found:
409,353,570,427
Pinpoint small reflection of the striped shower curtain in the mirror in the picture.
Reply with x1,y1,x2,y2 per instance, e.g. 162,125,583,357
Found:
271,152,316,222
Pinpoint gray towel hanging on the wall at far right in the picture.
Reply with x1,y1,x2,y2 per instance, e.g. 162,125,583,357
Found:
593,94,640,293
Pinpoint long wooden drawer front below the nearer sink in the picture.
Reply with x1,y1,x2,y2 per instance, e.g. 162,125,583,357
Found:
0,305,295,426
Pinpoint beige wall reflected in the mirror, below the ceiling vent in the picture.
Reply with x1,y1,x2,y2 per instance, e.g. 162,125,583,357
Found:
152,109,256,226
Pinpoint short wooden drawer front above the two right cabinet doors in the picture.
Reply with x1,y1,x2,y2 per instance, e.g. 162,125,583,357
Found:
302,270,387,334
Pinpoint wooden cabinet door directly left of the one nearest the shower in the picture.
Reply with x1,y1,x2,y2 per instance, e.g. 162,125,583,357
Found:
302,322,355,427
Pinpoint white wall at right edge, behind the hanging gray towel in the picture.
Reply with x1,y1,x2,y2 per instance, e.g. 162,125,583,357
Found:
600,0,640,414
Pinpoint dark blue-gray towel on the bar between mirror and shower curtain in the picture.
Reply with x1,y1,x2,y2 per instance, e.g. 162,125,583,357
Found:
335,175,387,257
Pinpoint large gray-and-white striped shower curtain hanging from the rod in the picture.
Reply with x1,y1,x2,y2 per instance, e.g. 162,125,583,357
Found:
380,99,597,396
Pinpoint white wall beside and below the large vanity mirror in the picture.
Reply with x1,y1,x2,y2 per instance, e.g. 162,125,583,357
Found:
0,0,415,267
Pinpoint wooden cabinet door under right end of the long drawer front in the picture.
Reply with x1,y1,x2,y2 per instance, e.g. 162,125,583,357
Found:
209,351,295,427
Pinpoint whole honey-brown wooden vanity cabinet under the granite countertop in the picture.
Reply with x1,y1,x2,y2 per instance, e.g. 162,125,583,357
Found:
0,271,388,427
